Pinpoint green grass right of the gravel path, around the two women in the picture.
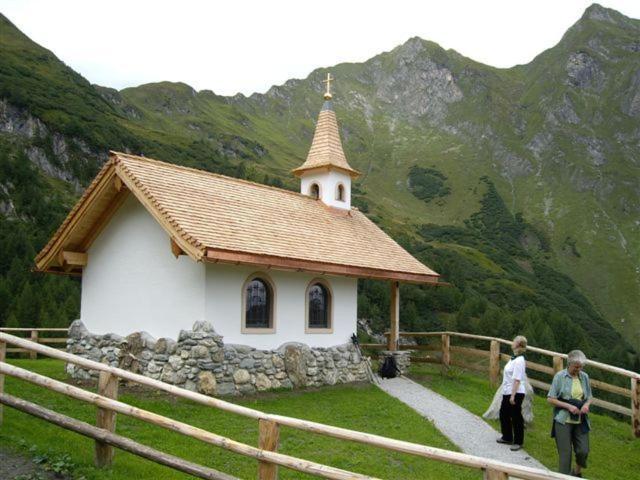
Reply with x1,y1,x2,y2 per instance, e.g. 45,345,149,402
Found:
411,364,640,480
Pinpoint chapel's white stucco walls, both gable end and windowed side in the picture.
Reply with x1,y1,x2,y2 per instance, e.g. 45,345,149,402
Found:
80,196,358,349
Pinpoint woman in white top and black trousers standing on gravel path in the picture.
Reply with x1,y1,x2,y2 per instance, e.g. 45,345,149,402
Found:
497,335,527,451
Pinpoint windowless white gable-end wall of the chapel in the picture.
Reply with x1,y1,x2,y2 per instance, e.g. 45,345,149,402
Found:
80,195,205,339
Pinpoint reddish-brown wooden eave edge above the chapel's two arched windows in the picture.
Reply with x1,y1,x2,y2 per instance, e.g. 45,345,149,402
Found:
203,248,440,285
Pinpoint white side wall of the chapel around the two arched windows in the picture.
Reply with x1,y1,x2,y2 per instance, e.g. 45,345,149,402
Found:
205,264,358,349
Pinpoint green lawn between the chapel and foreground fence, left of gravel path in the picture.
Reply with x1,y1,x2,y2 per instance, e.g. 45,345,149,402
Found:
0,360,480,480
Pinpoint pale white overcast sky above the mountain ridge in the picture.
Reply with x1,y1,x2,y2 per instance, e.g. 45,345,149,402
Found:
0,0,640,95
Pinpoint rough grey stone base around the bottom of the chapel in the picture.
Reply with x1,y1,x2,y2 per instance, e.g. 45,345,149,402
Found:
67,320,367,396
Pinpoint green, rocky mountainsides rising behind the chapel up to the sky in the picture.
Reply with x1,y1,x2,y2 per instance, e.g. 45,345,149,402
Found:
0,5,640,366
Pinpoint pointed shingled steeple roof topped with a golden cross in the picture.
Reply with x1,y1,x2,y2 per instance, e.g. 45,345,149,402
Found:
293,75,360,177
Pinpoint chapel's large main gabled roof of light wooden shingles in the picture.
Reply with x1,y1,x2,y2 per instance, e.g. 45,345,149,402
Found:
36,152,438,283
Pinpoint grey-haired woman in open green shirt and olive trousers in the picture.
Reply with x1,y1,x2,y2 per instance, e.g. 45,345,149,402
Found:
547,350,593,477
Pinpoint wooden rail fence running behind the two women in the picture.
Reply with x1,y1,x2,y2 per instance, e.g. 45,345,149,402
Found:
361,332,640,438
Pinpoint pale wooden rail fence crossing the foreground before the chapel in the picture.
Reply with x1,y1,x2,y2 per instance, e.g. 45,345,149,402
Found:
0,333,572,480
